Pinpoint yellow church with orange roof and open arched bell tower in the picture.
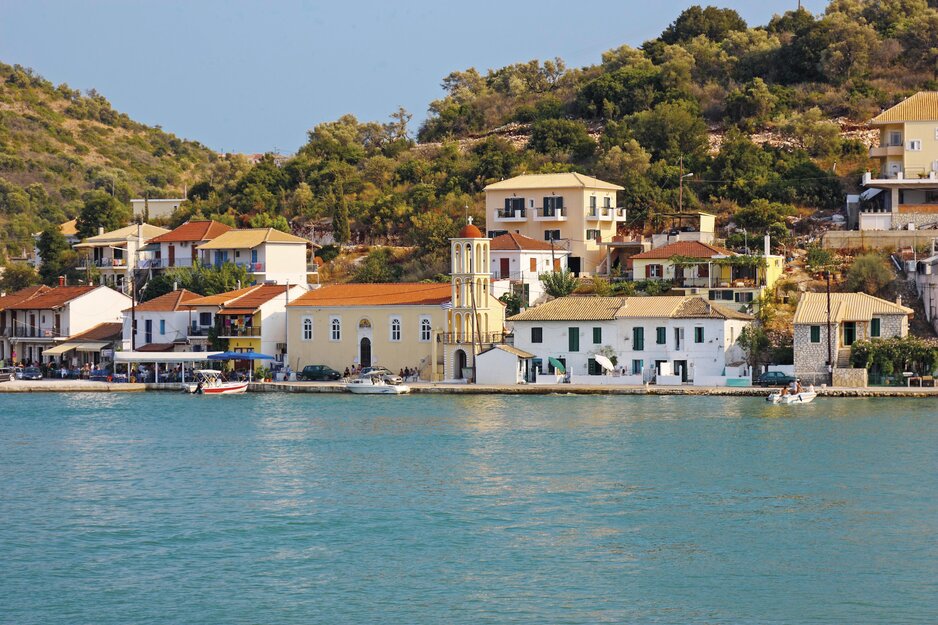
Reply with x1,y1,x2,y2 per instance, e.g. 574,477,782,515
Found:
287,218,505,382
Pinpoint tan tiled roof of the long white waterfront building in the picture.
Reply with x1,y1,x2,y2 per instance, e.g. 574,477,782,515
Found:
508,295,752,321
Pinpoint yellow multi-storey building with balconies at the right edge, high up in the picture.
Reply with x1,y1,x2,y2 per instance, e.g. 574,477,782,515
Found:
860,91,938,230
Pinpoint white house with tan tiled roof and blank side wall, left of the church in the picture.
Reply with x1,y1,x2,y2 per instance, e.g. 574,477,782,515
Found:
199,228,316,284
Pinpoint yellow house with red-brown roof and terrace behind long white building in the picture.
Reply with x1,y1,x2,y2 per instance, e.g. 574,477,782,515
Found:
629,240,785,310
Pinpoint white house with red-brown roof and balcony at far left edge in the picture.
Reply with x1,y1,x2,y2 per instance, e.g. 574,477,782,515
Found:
0,286,131,362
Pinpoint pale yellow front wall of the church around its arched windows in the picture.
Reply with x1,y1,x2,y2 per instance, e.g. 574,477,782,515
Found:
287,305,446,376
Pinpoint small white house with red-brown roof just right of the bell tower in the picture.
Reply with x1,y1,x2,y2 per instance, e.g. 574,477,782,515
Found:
490,232,570,306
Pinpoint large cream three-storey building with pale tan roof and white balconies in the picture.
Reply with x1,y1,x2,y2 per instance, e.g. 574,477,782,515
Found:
485,173,625,274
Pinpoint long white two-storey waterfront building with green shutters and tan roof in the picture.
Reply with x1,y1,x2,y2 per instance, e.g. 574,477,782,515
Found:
508,296,752,386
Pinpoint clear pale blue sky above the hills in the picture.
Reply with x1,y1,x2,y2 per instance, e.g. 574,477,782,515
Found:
0,0,826,153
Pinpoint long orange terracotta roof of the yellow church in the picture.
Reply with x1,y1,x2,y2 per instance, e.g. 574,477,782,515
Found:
288,282,452,307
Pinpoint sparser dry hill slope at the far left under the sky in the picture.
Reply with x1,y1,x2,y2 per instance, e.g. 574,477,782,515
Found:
0,63,218,251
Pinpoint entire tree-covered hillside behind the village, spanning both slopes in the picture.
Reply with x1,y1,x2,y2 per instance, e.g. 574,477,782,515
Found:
0,0,938,278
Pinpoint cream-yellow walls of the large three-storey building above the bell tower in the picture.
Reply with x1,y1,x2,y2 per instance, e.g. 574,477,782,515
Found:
485,188,617,273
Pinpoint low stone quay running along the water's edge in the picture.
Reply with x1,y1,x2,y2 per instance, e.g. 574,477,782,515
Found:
0,380,938,399
